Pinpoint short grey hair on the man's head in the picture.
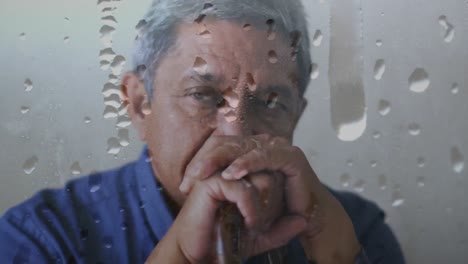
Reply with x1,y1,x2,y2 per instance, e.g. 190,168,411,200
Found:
133,0,311,100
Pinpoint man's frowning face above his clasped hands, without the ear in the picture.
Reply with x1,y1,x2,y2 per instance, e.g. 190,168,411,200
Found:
133,20,305,204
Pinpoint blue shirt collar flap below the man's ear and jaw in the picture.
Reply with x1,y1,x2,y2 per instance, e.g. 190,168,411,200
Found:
135,146,174,240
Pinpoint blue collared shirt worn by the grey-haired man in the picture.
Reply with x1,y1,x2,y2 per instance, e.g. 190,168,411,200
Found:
0,149,404,264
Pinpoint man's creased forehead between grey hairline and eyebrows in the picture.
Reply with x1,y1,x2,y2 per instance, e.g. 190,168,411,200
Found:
163,19,297,79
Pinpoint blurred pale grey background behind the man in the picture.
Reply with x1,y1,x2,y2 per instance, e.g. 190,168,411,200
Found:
0,0,468,263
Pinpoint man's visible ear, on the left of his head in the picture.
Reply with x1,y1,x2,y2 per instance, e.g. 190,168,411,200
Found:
120,72,151,141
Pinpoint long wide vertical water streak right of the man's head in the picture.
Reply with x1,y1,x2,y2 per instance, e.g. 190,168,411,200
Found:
327,1,368,142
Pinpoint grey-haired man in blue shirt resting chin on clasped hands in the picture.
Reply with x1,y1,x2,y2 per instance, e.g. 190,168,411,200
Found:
0,0,404,264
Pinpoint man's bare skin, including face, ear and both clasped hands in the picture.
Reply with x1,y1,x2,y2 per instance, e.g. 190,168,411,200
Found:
122,20,360,263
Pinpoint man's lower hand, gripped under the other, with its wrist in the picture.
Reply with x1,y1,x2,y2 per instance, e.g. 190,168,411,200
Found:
148,173,306,263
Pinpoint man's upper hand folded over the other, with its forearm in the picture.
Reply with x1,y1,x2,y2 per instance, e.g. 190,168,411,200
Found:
180,135,360,263
